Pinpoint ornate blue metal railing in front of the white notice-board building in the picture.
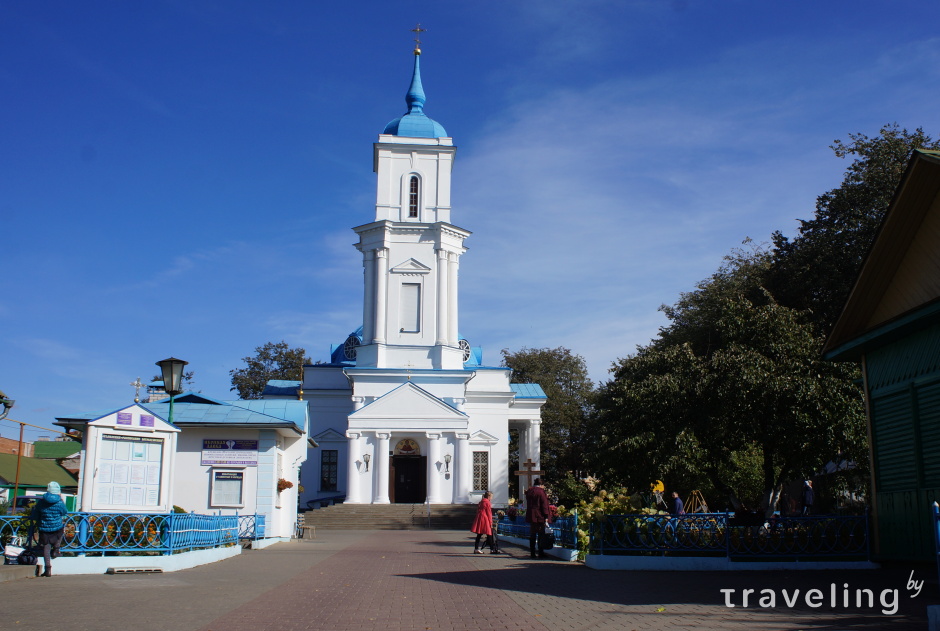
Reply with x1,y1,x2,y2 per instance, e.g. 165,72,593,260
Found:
0,513,264,555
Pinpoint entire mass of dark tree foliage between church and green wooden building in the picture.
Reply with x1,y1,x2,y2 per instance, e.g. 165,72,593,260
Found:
589,125,938,508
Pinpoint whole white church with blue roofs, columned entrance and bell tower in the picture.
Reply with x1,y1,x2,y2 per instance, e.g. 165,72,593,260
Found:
264,47,546,506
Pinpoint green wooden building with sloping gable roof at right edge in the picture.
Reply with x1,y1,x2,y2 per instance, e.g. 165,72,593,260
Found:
824,151,940,561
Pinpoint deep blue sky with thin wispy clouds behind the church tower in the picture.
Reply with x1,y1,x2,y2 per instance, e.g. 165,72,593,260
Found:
0,0,940,438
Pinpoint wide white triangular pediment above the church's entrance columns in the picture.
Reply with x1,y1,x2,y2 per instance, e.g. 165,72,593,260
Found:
349,381,469,431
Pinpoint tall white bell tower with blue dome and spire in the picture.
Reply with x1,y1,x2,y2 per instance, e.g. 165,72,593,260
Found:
353,37,470,369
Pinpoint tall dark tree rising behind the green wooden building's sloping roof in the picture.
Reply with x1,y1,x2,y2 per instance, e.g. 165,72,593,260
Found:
770,124,940,334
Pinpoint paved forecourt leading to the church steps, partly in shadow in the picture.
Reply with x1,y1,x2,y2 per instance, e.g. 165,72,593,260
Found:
0,531,940,631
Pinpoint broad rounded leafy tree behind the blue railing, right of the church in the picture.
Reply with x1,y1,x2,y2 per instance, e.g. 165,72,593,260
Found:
593,249,865,505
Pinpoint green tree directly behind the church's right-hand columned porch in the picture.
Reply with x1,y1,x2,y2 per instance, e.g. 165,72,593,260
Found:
502,346,594,481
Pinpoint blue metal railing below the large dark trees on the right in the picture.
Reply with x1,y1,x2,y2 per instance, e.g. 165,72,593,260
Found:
589,513,869,559
